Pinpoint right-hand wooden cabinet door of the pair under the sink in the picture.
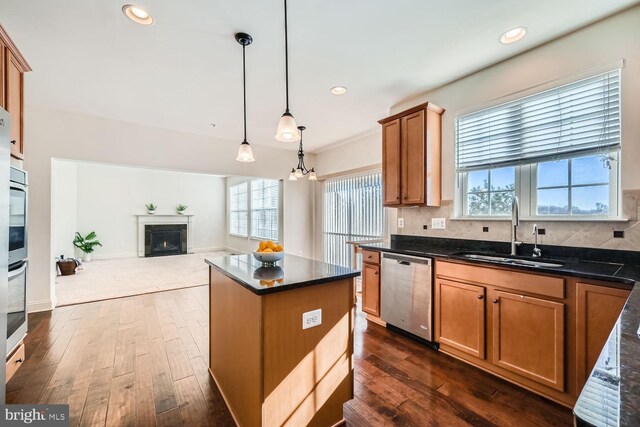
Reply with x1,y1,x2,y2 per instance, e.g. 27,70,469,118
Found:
492,291,564,391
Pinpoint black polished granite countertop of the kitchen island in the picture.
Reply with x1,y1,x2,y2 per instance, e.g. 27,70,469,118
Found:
205,254,360,295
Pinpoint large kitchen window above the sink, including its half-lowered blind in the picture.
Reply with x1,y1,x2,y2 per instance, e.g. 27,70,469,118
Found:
455,70,621,218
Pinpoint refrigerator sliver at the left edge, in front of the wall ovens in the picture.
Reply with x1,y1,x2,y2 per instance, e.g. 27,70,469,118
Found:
0,108,11,403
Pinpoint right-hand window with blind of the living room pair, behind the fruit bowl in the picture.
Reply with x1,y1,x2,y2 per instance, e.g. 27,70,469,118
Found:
251,179,280,241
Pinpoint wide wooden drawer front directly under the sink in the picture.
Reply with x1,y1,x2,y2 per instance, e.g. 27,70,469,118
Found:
436,261,565,299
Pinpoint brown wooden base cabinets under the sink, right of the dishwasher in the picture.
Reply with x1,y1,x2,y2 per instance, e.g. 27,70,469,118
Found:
434,259,631,407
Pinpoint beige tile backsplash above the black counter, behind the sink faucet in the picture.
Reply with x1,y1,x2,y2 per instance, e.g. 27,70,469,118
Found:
397,190,640,251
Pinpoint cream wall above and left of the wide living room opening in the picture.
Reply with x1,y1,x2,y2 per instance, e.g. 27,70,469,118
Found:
24,108,312,311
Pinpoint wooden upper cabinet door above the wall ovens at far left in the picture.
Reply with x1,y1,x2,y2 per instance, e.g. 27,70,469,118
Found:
5,51,23,159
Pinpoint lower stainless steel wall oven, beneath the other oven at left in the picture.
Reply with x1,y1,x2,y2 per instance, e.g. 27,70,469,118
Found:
7,261,27,354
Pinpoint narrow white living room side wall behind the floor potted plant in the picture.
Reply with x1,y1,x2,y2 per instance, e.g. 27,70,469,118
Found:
51,161,78,257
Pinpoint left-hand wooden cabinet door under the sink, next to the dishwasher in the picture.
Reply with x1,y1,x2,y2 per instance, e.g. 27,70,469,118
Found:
435,279,485,359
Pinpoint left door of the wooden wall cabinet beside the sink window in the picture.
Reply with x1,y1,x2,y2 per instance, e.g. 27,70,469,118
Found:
382,119,402,206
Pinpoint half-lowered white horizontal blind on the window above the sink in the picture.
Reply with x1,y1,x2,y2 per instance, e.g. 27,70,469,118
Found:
456,69,621,172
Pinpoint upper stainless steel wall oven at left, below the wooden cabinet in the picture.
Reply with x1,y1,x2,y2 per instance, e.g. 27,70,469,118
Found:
9,167,28,265
